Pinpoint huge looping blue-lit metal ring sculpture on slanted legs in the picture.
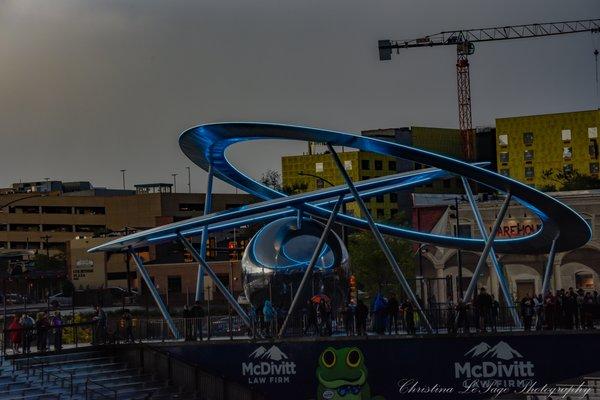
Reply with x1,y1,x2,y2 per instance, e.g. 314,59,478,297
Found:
90,123,591,333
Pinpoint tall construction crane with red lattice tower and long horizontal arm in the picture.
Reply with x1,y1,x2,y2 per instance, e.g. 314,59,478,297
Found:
379,19,600,160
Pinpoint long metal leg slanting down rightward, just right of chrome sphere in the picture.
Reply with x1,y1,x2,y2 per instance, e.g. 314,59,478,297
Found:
327,143,432,332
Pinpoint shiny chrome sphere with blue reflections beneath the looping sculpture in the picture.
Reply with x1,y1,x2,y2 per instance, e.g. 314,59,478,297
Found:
242,217,349,309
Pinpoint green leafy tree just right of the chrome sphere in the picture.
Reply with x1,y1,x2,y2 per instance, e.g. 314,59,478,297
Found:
348,220,415,295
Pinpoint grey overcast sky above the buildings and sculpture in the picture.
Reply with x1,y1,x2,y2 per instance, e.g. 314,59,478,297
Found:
0,0,600,191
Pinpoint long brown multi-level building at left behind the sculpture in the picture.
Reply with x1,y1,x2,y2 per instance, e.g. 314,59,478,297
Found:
0,181,254,287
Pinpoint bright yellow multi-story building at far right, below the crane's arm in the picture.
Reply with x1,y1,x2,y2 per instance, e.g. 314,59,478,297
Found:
496,110,600,188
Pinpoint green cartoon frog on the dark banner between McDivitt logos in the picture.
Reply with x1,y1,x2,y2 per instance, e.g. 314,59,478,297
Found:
317,347,384,400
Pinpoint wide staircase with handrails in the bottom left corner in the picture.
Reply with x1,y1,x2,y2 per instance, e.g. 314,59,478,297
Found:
0,350,194,400
